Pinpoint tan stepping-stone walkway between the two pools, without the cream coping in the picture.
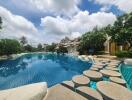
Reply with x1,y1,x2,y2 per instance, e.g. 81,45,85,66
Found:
43,55,132,100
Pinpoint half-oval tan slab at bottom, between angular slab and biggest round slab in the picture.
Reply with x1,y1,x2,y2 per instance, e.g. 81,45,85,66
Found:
76,86,103,100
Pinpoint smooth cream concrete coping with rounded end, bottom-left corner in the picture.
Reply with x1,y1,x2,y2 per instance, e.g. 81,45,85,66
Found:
0,82,47,100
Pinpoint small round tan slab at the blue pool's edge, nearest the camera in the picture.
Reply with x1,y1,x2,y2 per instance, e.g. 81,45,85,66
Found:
72,75,90,85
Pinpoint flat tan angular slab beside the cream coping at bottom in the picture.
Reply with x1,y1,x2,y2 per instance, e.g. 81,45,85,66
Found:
43,84,87,100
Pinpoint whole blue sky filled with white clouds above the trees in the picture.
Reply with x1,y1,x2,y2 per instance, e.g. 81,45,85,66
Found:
0,0,132,44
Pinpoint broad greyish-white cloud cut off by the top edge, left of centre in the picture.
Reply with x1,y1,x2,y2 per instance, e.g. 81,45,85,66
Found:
13,0,81,16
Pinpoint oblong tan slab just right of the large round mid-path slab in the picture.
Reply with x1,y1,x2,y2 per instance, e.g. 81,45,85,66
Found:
100,69,121,77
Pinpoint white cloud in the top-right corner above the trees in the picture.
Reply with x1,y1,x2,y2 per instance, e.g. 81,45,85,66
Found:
92,0,132,13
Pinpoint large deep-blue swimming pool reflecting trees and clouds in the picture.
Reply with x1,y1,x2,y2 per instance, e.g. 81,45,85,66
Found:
0,53,91,90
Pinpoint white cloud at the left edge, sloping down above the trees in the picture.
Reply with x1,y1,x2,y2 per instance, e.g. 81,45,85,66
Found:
0,6,38,42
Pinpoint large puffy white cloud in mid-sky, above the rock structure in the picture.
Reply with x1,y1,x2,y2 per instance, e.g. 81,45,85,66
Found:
41,11,116,41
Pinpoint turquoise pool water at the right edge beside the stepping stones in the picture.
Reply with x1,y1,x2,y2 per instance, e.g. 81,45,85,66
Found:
120,64,132,90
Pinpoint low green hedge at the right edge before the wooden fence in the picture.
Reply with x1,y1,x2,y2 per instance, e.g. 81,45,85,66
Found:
116,51,132,58
